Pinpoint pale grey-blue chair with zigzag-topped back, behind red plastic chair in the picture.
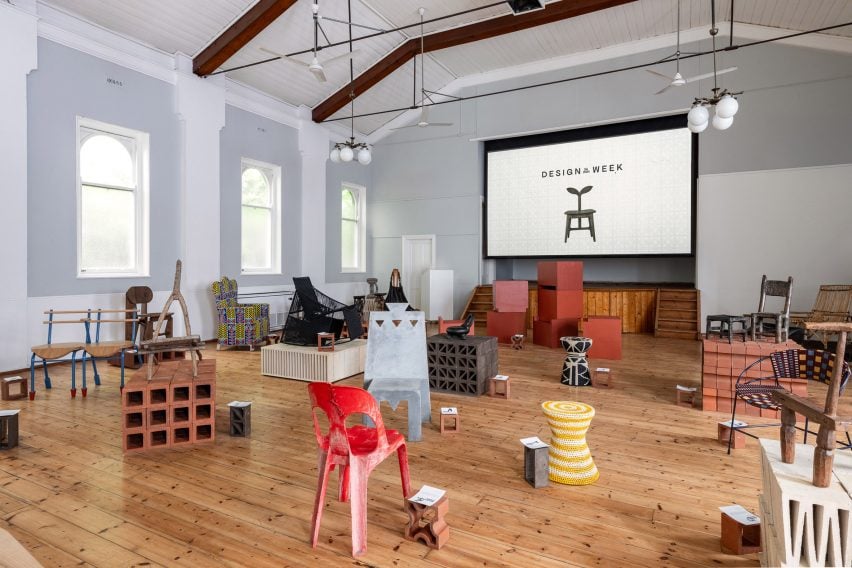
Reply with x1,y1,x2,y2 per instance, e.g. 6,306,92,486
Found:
364,304,432,442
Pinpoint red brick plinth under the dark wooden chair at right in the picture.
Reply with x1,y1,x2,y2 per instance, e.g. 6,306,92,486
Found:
701,338,808,419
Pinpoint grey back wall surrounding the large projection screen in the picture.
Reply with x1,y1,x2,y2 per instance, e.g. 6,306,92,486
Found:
373,40,852,302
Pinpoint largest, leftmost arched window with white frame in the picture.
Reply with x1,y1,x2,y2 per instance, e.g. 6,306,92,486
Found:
77,118,148,277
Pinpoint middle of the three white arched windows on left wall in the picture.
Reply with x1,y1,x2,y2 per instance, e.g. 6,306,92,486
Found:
240,158,281,274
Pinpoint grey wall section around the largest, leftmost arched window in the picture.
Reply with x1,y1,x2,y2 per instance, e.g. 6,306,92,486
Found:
27,38,180,297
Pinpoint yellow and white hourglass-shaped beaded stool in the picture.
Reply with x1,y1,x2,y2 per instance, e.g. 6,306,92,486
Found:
541,400,600,485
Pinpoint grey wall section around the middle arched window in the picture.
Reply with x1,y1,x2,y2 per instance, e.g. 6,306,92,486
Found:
219,105,302,286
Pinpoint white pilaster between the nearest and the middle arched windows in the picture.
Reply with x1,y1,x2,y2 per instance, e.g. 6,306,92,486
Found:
174,54,225,339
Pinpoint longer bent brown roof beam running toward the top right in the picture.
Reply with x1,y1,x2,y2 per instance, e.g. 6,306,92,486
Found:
313,0,635,122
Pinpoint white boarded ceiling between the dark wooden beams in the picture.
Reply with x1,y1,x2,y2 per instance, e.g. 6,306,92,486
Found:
44,0,852,133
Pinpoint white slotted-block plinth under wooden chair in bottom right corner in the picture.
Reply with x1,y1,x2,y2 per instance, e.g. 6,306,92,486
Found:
760,440,852,566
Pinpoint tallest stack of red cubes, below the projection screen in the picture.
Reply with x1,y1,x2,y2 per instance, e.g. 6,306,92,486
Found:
533,261,583,348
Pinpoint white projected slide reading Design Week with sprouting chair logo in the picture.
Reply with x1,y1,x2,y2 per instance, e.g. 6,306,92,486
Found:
486,128,692,256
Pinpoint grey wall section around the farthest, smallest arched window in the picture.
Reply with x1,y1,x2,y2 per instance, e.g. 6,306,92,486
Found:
325,156,372,282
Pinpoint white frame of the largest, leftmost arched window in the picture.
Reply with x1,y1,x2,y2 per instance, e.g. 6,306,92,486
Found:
75,116,151,279
